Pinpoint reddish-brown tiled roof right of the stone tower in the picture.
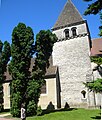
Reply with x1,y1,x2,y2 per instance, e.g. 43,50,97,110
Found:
91,38,102,57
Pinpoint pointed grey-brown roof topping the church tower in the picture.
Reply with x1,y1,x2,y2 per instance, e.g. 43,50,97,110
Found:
52,0,83,29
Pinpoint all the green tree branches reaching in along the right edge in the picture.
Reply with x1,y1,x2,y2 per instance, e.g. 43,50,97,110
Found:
84,0,102,117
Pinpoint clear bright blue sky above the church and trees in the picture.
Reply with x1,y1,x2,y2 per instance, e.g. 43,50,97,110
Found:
0,0,100,43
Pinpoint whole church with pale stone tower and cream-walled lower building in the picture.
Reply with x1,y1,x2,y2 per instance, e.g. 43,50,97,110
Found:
3,0,102,109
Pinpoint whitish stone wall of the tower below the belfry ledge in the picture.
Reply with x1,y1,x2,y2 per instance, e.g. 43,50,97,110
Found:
52,36,94,107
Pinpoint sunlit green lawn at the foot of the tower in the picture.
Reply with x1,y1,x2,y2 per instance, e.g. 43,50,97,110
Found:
4,109,100,120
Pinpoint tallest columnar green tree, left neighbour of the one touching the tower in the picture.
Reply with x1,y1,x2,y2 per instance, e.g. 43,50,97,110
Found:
9,23,34,117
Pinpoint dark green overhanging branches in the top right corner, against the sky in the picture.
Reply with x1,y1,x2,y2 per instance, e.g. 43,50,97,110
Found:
84,0,102,36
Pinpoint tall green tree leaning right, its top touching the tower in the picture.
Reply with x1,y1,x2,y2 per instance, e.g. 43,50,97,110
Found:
27,30,57,115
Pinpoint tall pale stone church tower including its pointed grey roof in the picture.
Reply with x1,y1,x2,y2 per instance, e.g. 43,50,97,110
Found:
52,0,95,107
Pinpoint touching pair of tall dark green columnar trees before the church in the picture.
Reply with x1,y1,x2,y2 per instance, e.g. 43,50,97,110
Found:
9,23,57,117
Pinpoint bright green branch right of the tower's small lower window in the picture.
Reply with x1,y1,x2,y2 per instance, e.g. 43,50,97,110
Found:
84,78,102,93
